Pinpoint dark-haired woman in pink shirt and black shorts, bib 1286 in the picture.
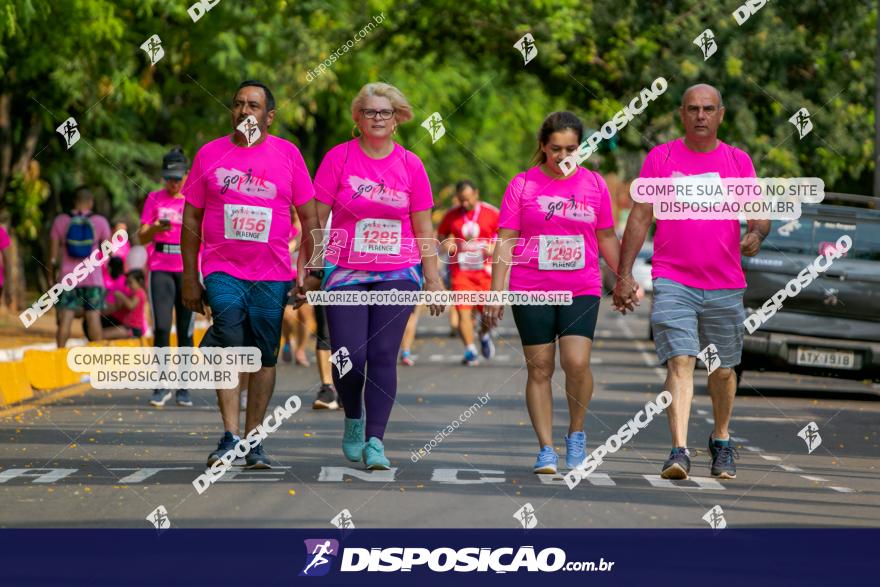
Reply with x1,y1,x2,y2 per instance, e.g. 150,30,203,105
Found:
486,112,620,473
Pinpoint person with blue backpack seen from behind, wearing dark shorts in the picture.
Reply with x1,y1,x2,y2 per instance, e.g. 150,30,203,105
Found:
49,187,111,348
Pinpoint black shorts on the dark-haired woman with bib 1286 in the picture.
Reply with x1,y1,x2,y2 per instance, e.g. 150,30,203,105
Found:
511,296,599,346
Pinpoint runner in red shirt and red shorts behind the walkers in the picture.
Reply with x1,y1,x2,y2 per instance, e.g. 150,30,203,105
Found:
437,179,498,366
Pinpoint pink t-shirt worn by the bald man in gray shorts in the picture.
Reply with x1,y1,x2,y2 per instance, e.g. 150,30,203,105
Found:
639,139,755,289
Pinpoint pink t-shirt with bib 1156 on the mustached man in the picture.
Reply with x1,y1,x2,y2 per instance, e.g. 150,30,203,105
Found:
182,135,315,281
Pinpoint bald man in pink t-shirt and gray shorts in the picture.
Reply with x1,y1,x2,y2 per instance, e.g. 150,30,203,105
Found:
614,84,770,479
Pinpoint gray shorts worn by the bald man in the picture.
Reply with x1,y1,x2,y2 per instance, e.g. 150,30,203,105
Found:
651,277,746,367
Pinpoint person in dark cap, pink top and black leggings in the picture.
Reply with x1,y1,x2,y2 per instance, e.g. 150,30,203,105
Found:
138,147,195,407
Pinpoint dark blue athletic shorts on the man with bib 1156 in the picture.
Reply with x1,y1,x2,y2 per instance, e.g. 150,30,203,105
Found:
199,271,291,367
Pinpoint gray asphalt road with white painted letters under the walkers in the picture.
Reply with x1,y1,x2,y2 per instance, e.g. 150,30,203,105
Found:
0,302,880,528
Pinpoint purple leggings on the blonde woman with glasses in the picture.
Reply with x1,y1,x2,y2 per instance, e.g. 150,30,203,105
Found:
327,280,419,440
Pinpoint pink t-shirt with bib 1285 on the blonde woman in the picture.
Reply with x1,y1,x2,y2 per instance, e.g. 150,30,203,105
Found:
315,139,434,271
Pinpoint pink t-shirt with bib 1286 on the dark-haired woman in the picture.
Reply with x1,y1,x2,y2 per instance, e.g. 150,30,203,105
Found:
498,167,614,296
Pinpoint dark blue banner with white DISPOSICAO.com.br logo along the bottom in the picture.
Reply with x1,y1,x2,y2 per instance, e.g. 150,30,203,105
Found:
0,528,880,587
